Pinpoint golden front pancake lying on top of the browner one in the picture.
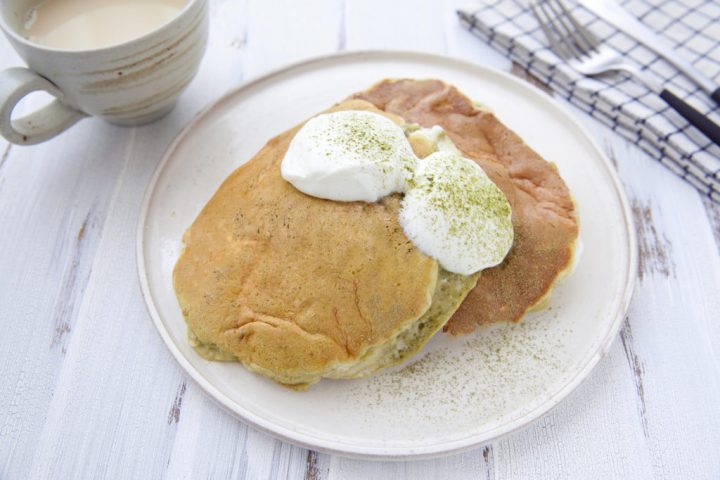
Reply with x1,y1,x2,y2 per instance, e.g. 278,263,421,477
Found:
173,100,478,388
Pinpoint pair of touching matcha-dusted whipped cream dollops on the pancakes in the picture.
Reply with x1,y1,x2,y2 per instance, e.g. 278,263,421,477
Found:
281,110,513,275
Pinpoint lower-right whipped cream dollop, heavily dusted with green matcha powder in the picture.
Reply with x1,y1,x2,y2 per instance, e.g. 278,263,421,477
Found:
400,151,513,275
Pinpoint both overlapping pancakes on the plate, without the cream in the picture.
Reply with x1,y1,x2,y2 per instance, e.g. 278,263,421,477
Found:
174,80,578,388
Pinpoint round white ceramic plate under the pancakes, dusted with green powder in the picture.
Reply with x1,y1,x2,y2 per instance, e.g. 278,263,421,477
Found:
137,52,636,459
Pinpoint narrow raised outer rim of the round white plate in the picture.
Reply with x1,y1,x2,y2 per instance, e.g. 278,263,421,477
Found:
135,50,638,460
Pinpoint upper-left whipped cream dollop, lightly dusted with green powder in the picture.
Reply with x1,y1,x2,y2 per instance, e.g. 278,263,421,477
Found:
280,110,417,202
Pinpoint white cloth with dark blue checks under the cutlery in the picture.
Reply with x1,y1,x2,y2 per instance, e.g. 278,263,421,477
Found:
458,0,720,202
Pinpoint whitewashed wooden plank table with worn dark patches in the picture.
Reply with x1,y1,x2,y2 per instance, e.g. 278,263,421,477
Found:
0,0,720,480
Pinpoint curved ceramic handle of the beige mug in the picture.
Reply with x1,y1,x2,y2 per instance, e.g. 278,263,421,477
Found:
0,67,87,145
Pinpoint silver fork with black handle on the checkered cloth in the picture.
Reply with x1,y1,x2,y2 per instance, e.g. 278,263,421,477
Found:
530,0,720,145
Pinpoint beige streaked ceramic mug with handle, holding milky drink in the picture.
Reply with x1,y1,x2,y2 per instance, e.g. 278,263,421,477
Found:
0,0,208,145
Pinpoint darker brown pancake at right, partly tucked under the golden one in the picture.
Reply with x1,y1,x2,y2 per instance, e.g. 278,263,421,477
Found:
354,80,578,334
